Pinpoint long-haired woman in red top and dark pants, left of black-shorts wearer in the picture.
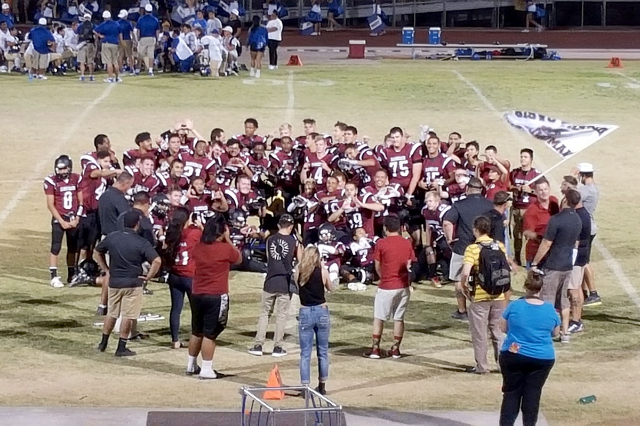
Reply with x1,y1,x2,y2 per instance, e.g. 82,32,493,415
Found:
164,207,203,349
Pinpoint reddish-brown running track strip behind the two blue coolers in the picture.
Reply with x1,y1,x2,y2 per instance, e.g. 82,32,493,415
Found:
282,28,640,49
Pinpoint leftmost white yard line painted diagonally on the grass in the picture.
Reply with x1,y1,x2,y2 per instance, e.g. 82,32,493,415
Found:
0,84,116,230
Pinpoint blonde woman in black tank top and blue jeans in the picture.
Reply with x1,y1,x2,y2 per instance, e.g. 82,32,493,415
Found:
296,246,331,395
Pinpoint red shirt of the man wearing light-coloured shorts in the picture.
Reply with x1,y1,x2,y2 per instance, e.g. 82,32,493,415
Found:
373,235,416,290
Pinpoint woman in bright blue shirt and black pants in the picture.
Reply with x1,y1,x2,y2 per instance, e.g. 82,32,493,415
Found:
500,271,560,426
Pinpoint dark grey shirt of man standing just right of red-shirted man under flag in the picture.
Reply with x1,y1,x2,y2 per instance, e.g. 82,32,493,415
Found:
542,208,582,271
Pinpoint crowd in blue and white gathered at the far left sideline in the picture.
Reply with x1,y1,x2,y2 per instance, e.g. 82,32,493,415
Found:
0,2,283,78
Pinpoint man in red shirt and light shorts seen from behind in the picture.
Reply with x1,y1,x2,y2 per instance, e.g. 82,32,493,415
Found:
364,216,415,359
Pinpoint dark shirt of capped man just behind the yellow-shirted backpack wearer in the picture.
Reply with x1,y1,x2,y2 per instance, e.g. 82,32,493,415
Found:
444,194,502,256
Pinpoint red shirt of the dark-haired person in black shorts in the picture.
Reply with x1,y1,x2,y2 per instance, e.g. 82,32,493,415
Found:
193,241,240,296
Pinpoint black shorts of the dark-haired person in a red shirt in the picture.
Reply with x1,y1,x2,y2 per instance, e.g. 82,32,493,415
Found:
191,294,229,340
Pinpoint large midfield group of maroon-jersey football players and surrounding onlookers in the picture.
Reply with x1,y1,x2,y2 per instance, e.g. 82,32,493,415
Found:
44,118,601,424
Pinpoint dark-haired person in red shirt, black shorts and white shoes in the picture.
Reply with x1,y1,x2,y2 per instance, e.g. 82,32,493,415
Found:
186,216,242,379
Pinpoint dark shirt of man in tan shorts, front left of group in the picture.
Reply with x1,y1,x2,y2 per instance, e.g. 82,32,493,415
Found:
96,228,158,288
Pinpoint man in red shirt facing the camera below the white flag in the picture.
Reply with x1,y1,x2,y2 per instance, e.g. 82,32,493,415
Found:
522,177,560,269
